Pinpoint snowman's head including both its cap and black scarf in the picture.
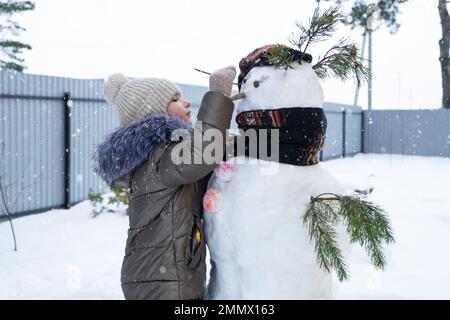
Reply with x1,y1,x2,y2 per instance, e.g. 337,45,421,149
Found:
236,45,327,166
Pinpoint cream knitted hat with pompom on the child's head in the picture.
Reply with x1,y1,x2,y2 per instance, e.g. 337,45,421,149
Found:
103,73,181,126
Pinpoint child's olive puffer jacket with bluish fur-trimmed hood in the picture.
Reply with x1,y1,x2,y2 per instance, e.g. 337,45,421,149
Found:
92,92,233,299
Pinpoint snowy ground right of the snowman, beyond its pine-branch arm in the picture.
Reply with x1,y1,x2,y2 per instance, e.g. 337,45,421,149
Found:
324,155,450,299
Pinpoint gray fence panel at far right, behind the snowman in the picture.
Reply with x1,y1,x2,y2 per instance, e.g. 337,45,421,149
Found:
364,109,450,157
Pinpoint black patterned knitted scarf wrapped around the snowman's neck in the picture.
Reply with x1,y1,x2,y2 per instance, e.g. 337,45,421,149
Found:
236,108,327,166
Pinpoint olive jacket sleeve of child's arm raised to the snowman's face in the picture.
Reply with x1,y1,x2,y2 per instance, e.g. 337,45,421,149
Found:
149,91,234,187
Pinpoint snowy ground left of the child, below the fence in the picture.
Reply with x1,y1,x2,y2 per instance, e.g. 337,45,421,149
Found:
0,201,128,299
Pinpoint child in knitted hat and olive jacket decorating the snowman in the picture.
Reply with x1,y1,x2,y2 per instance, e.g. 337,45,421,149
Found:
94,67,236,300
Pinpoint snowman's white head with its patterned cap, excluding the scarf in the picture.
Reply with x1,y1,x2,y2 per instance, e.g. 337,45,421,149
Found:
237,45,324,113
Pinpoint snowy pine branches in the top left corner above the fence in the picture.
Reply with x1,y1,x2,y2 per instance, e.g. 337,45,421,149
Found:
0,0,35,72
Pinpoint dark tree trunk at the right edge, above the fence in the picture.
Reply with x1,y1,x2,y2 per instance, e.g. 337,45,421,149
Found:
438,0,450,109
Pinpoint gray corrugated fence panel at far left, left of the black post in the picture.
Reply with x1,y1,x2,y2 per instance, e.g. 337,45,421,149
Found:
0,98,64,214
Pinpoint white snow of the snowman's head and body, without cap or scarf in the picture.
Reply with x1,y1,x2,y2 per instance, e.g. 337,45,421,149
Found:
204,62,346,299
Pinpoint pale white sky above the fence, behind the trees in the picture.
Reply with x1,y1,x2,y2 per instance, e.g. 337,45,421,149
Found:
13,0,441,109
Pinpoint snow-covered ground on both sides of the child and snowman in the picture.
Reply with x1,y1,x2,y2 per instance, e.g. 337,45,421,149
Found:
0,155,450,299
